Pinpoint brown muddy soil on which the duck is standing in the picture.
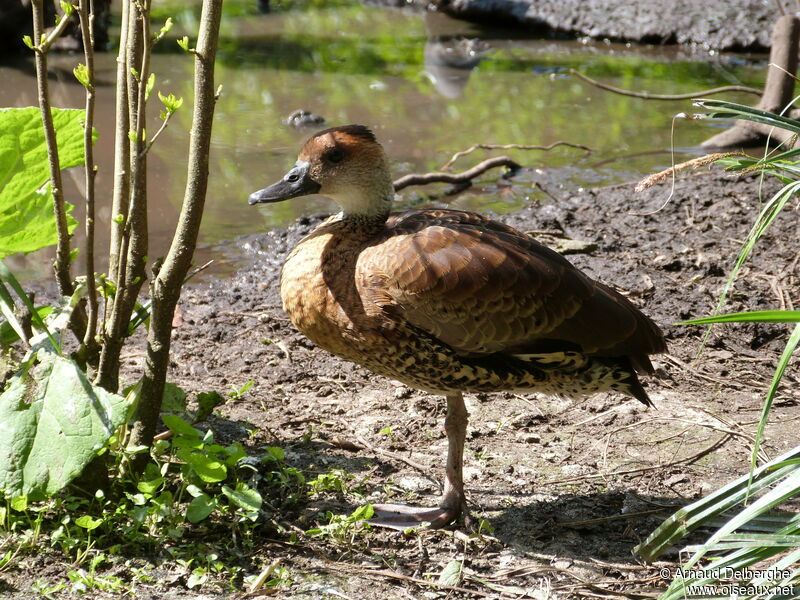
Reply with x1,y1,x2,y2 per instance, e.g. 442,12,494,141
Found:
4,166,800,600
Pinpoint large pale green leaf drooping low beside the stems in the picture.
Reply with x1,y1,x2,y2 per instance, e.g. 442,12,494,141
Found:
0,350,127,498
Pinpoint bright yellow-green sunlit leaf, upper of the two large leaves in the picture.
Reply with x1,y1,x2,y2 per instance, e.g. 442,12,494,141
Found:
0,108,85,258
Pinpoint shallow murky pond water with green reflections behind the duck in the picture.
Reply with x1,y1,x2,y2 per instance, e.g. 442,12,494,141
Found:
0,0,766,277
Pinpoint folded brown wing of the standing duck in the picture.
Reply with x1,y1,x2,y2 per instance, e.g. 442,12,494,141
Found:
356,210,665,371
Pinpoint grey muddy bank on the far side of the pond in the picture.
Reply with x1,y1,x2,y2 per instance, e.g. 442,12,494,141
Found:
368,0,780,51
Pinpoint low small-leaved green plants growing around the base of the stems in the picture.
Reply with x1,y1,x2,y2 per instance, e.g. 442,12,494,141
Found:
0,408,318,597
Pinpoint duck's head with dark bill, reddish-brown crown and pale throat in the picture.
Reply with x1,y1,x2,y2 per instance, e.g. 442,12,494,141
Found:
248,125,394,217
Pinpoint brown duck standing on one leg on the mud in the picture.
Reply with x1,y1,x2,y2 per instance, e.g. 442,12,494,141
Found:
249,125,666,529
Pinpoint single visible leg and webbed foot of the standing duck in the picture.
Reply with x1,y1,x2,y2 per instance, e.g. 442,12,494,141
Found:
370,392,468,531
